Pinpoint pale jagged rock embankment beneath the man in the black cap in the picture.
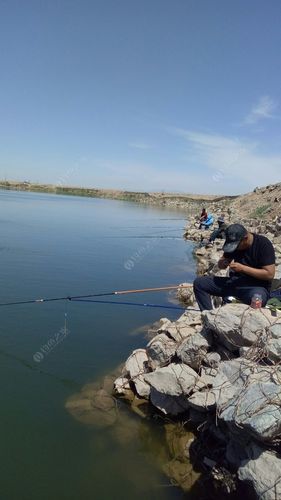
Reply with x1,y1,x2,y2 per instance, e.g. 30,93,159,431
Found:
111,214,281,500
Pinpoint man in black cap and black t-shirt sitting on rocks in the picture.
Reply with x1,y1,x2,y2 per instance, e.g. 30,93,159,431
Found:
193,224,275,311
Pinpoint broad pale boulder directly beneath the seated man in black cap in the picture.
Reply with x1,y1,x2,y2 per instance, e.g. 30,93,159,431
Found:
202,304,276,352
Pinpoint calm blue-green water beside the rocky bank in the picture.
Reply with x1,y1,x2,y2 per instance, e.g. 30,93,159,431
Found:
0,191,194,500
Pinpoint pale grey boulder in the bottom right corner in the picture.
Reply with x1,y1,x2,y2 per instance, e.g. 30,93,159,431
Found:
238,443,281,500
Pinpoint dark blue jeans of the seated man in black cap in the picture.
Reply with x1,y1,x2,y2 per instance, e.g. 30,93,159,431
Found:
193,276,270,311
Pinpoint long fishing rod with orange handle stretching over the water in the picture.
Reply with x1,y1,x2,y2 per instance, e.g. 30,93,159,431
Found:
0,283,193,307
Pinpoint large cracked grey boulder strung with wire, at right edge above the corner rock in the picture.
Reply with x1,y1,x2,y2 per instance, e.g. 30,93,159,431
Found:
212,364,281,442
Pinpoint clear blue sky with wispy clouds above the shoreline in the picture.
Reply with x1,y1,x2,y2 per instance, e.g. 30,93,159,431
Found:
0,0,281,194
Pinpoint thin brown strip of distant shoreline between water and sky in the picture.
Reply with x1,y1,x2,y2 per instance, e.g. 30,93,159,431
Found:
0,180,238,208
